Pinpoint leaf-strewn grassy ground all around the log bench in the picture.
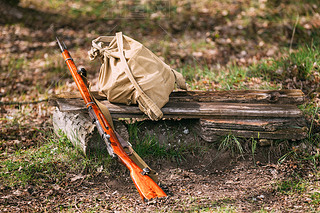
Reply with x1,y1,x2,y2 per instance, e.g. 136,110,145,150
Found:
0,0,320,212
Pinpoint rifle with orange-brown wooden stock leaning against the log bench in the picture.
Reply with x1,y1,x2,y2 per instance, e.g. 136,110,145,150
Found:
56,38,167,201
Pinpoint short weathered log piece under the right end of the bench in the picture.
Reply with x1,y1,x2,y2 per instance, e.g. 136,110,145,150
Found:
197,117,308,142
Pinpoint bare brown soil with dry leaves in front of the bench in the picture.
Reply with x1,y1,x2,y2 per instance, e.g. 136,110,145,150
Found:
0,143,316,212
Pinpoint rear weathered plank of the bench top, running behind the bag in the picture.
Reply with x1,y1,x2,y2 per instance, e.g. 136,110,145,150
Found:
52,89,304,104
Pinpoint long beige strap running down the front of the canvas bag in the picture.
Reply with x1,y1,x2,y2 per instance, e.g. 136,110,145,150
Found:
116,32,163,120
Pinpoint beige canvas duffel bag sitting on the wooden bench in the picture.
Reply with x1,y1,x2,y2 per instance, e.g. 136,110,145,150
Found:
89,32,186,120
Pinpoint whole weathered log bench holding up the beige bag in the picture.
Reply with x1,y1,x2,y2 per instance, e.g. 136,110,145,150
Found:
51,90,308,149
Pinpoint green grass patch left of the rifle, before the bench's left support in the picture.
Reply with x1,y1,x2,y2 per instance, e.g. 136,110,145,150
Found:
0,133,111,187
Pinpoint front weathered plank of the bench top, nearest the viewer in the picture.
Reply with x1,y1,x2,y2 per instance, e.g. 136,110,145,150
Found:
56,99,302,118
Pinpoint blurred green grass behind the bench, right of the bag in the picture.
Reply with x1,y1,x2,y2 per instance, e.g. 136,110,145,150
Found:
175,30,320,90
